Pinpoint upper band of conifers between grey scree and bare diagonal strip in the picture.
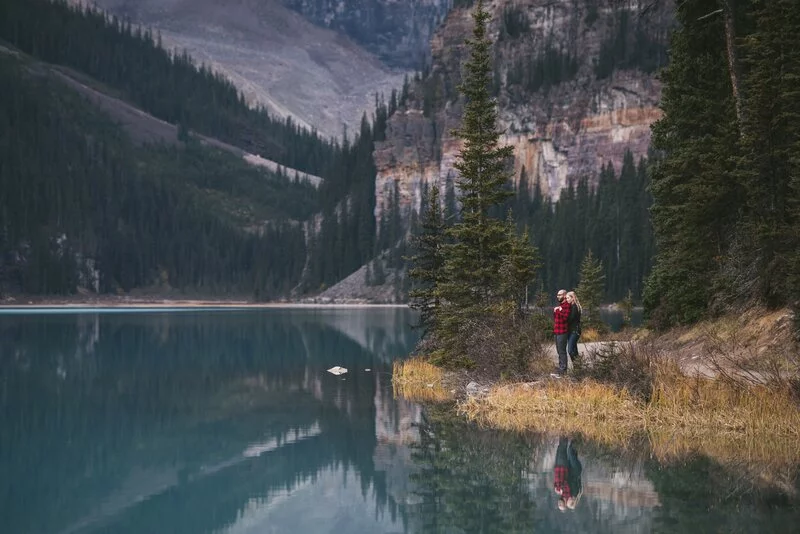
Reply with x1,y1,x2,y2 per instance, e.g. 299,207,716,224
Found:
0,0,337,175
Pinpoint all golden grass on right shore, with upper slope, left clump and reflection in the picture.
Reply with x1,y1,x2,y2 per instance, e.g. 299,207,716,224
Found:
395,310,800,483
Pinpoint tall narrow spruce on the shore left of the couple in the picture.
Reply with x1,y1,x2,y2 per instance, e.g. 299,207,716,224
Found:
434,0,536,373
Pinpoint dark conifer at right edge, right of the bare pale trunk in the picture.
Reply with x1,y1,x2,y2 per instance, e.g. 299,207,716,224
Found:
729,0,800,306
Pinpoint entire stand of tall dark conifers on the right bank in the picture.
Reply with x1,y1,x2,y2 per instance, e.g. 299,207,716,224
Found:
645,0,800,326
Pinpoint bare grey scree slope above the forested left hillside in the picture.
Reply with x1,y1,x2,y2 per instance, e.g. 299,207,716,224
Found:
84,0,410,136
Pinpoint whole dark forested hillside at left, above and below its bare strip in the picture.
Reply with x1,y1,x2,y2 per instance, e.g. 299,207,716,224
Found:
0,0,387,298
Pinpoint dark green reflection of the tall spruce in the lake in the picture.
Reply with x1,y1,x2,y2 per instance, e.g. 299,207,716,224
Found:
408,406,534,533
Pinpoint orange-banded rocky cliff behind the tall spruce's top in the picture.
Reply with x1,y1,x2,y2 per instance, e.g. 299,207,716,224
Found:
375,0,673,225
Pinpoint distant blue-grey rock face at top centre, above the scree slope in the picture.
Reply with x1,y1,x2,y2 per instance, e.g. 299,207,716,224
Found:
282,0,451,69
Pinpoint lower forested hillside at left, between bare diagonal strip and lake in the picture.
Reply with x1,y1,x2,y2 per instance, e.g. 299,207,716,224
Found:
0,53,316,298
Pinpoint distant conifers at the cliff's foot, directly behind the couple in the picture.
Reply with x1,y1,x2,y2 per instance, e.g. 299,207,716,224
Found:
514,152,655,302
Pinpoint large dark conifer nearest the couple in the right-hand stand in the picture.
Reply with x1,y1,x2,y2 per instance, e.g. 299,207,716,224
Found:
644,0,741,327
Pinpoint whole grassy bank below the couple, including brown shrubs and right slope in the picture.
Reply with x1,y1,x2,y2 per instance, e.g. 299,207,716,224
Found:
394,310,800,474
